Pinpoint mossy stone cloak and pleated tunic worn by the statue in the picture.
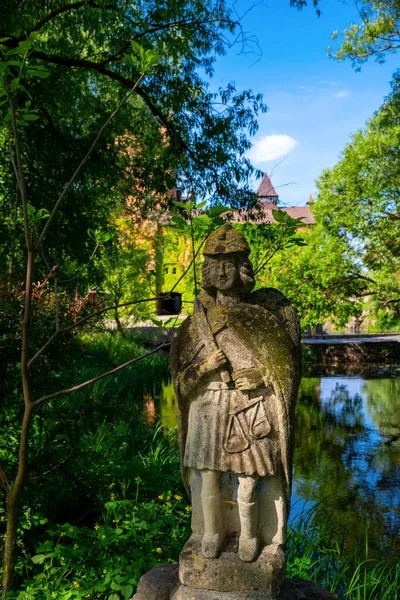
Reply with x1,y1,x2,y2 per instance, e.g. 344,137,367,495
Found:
171,288,301,543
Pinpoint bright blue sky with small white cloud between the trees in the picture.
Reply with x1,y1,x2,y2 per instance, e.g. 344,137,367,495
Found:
211,0,399,206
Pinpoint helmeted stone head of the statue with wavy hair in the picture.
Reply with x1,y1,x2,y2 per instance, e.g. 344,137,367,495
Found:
201,223,255,298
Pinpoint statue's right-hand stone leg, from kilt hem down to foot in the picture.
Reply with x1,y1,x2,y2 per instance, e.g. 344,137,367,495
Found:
238,475,258,562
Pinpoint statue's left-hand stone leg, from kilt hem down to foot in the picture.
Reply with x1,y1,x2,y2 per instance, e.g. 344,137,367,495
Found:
201,471,225,558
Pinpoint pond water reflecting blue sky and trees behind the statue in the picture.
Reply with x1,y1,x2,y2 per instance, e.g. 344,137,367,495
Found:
155,373,400,555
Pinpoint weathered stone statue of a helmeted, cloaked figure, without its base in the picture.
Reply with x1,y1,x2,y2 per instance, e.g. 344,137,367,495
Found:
171,224,301,583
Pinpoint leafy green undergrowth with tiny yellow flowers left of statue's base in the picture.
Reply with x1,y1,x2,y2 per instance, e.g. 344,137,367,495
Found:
6,487,190,600
